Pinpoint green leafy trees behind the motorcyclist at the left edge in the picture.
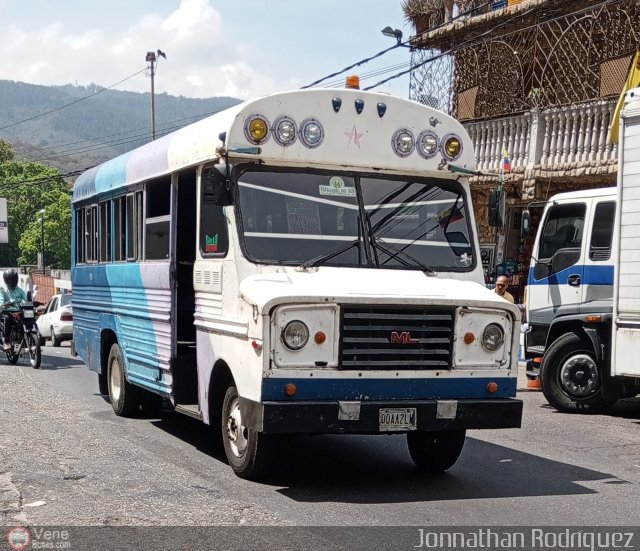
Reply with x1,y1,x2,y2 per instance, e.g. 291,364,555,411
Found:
0,142,71,268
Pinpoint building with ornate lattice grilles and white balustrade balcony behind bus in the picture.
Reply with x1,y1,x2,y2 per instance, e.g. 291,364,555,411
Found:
403,0,640,301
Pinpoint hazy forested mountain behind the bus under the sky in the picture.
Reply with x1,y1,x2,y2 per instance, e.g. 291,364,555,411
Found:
0,80,240,174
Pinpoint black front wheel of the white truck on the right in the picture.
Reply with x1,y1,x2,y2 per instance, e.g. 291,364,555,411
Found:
540,333,613,412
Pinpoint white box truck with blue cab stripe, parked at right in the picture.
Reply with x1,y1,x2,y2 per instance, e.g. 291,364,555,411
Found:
523,89,640,411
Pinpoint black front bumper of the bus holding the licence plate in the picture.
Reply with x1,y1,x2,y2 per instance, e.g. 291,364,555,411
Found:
240,398,522,434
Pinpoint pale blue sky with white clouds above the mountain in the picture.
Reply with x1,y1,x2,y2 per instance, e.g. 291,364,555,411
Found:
0,0,412,99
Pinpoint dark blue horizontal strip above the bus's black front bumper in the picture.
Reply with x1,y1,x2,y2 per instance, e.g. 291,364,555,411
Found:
262,377,516,401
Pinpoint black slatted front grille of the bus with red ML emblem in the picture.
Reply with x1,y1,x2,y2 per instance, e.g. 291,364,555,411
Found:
340,306,455,370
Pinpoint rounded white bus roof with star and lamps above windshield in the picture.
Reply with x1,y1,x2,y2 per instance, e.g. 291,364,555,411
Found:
73,89,475,201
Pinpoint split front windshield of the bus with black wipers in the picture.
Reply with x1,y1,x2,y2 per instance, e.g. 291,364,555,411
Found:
238,167,474,271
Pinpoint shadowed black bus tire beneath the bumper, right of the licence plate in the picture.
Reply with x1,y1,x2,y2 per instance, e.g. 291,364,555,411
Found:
407,429,467,473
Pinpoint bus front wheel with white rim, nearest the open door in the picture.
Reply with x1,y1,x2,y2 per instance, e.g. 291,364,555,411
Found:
222,385,273,480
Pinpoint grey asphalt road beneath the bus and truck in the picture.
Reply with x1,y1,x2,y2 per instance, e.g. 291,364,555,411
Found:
0,346,640,526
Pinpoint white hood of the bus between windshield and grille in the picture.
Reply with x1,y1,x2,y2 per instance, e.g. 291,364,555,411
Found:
240,267,520,318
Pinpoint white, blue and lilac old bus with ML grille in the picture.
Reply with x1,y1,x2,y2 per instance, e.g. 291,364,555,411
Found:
72,77,522,478
